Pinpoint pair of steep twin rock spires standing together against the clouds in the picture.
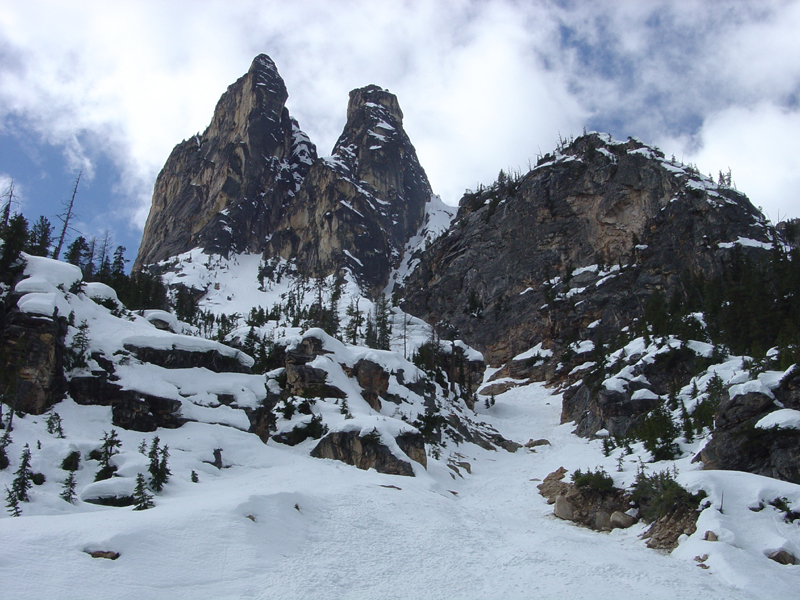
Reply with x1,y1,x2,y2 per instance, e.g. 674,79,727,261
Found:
133,54,431,292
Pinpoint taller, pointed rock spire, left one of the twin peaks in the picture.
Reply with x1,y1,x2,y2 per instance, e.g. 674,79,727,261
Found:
134,54,316,269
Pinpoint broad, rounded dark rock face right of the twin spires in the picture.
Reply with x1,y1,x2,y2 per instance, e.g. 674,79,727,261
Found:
404,134,768,368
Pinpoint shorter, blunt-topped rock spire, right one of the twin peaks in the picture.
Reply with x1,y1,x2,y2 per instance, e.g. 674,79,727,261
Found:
265,85,431,291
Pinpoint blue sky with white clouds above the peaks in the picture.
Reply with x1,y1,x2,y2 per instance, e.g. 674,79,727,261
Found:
0,0,800,259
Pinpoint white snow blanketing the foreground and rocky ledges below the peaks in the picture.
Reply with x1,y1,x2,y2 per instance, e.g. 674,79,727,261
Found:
0,253,800,600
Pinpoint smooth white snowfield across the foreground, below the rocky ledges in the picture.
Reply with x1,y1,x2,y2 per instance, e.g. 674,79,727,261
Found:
0,385,800,600
